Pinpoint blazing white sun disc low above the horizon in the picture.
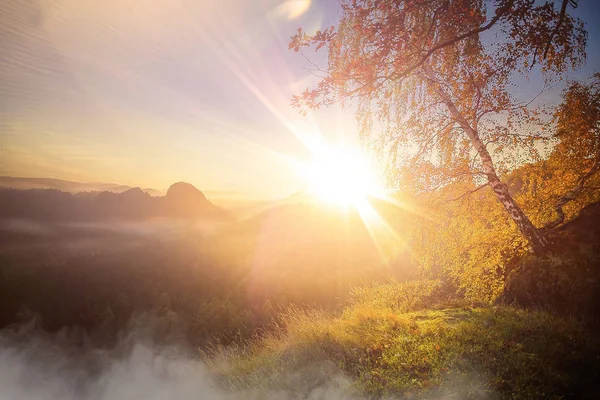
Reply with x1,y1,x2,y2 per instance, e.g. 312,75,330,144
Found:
303,147,384,207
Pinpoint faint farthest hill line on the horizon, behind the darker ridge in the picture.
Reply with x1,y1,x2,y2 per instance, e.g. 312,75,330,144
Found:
0,176,164,196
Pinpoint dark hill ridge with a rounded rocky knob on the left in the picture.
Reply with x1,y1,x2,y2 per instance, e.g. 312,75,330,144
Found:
0,182,231,222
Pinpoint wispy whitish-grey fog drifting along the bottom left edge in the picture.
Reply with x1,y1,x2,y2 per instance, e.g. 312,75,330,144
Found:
0,316,358,400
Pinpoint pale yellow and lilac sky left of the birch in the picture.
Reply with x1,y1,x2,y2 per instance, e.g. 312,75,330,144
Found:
0,0,600,199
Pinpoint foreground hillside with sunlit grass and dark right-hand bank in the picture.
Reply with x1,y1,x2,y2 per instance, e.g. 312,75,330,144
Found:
208,203,600,399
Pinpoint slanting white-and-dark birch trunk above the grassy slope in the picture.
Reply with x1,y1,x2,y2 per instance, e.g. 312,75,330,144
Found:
425,69,548,255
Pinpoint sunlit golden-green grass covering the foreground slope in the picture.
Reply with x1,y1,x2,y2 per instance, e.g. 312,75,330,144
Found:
207,284,600,399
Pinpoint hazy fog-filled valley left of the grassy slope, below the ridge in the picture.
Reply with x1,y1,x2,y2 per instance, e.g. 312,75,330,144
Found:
0,192,484,400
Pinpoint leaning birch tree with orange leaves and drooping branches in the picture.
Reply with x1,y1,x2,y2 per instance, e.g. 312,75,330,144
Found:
290,0,586,254
